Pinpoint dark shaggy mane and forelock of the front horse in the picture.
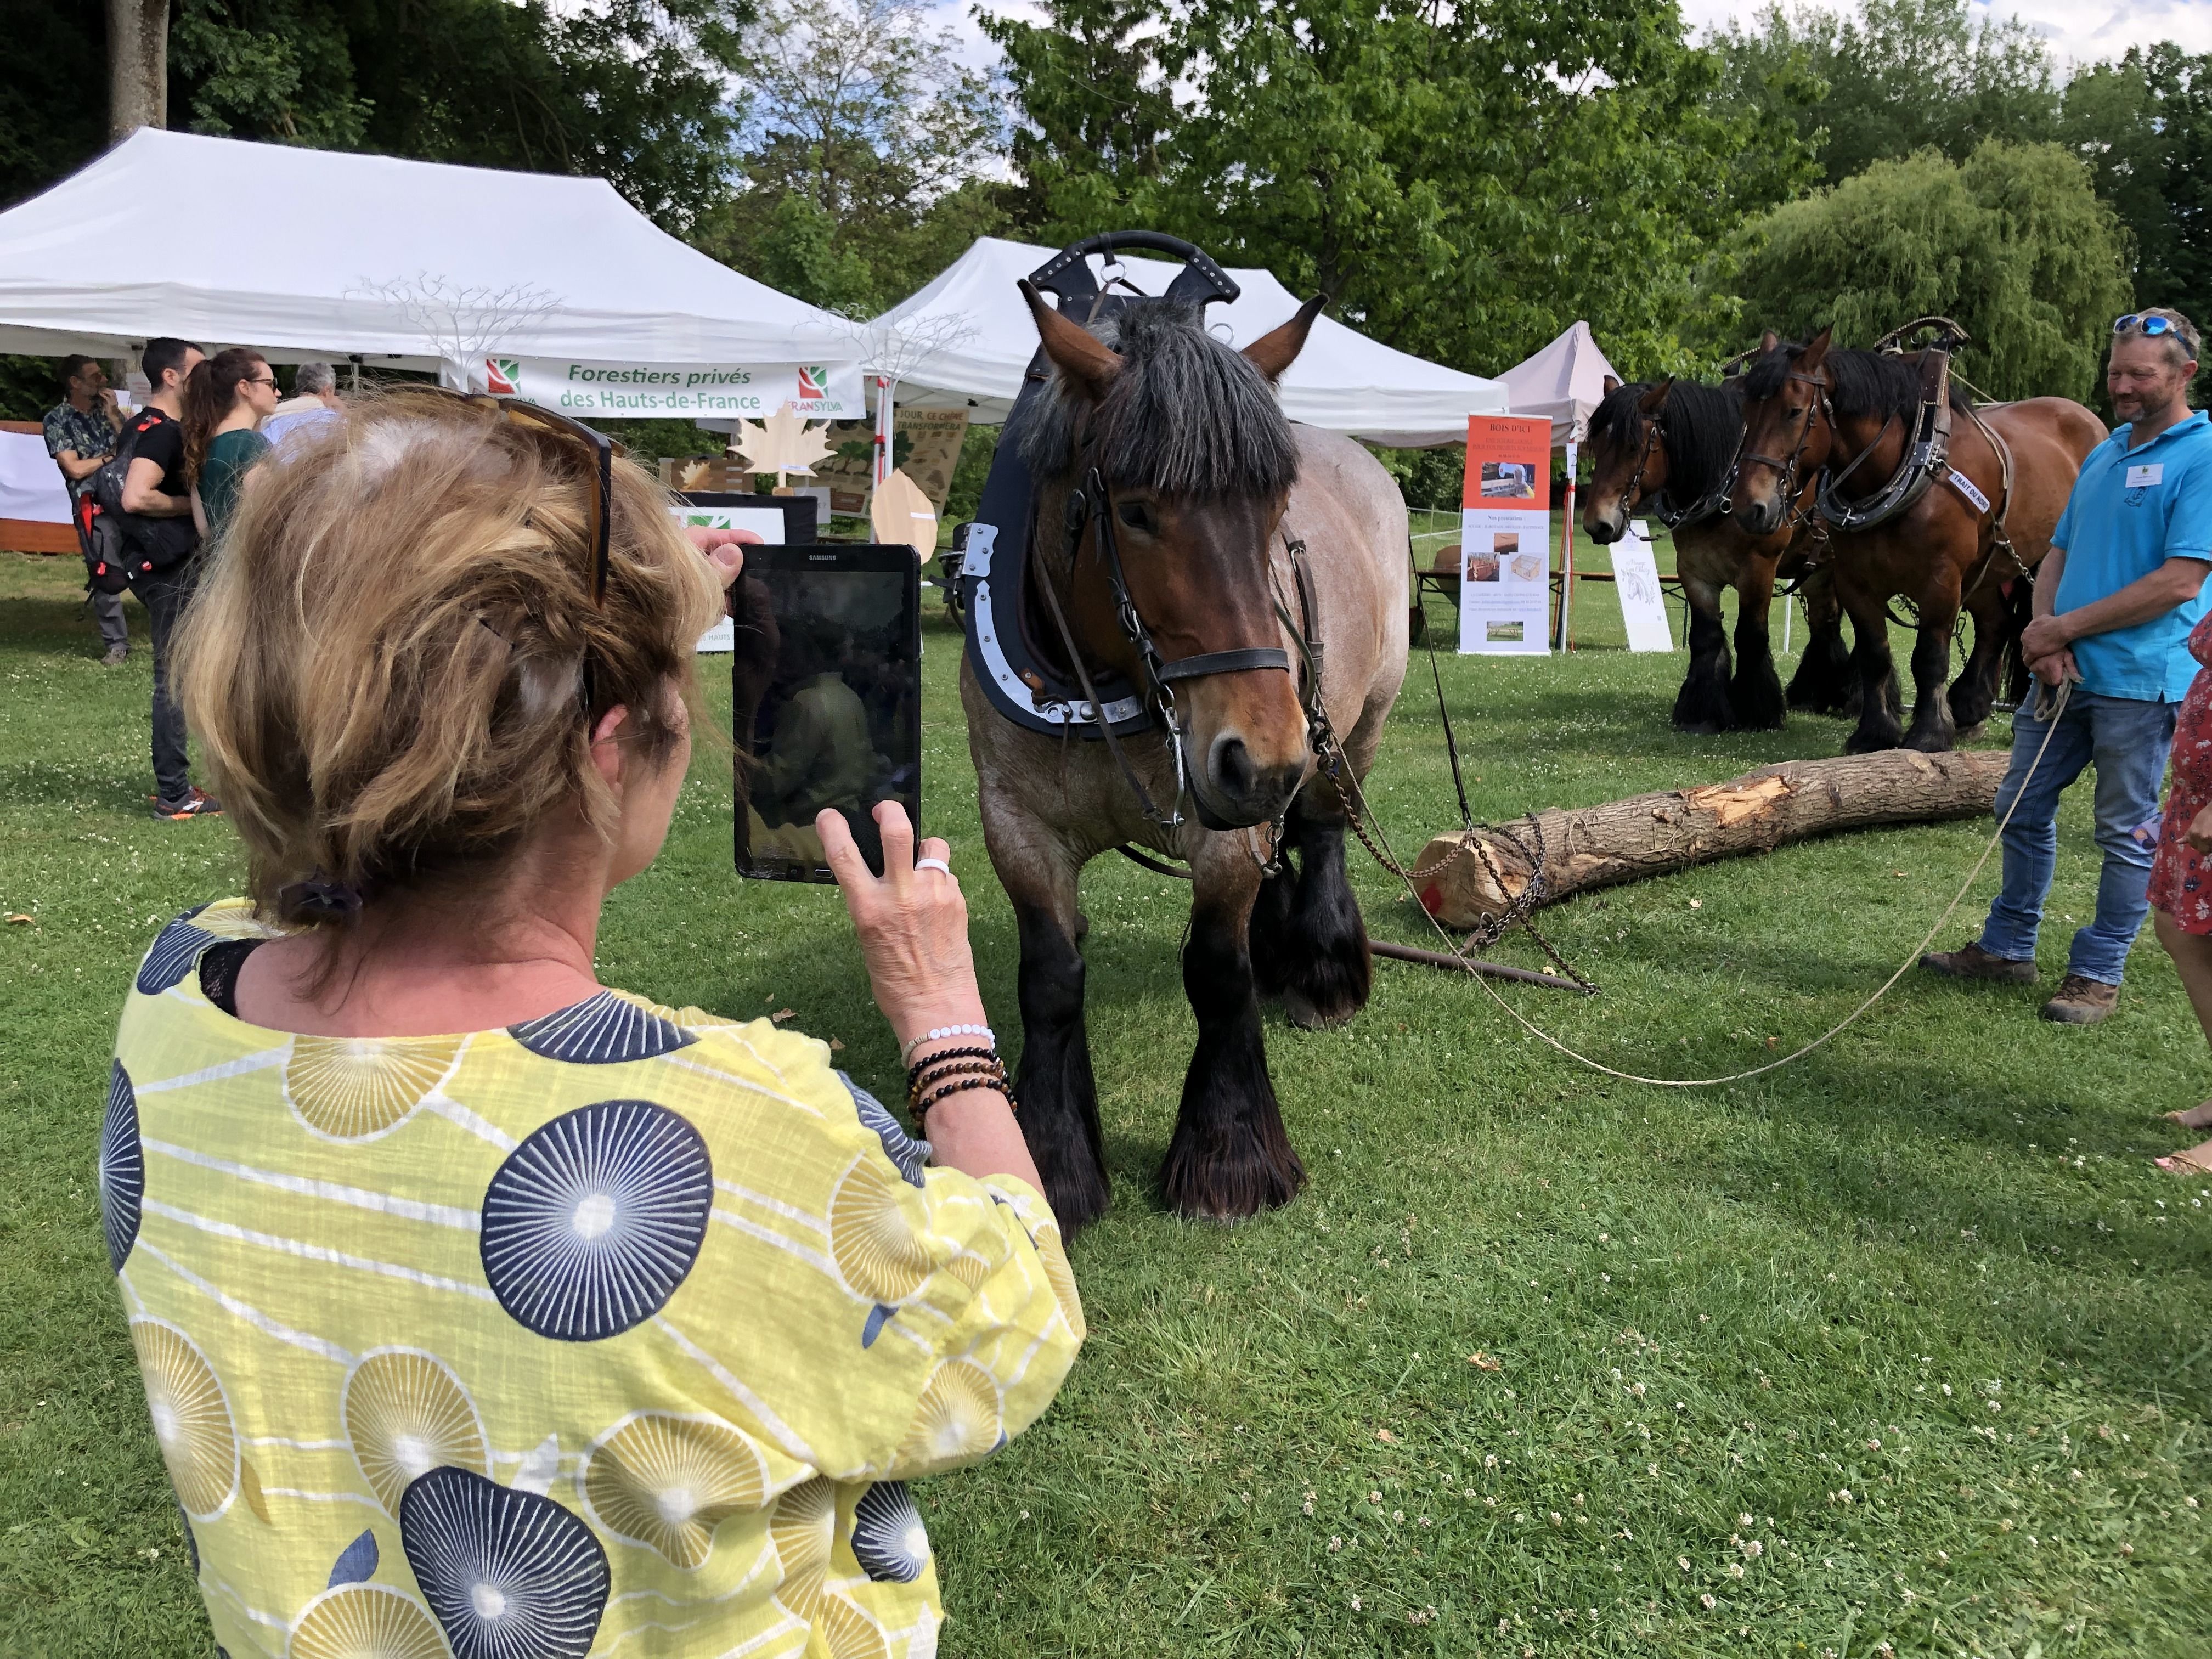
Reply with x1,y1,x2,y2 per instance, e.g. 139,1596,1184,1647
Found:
1020,301,1299,498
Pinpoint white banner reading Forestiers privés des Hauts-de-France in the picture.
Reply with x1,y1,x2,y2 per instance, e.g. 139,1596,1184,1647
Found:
469,356,867,420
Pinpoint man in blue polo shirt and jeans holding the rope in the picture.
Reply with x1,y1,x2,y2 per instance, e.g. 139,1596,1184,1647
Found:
1920,309,2212,1024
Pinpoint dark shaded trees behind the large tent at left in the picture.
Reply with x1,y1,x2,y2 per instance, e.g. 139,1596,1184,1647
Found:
0,0,752,230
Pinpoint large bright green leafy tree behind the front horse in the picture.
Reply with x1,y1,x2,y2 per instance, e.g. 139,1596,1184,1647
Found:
993,0,1805,369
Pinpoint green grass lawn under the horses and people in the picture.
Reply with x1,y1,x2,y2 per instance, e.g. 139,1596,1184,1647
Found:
0,555,2212,1659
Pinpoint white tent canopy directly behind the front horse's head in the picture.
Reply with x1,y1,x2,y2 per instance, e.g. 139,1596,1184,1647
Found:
872,236,1506,447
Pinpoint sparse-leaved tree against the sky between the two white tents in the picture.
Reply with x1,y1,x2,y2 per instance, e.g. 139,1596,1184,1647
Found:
695,0,1002,314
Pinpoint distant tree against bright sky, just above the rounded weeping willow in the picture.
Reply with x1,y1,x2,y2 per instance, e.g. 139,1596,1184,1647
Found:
1710,0,2059,179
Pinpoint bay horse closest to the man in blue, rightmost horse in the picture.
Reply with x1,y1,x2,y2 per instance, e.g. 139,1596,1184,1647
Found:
1730,330,2106,754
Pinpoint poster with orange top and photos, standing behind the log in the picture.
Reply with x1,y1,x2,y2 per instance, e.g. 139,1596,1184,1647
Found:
1460,416,1550,657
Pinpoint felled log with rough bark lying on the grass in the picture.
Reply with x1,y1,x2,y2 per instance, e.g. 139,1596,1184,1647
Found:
1413,750,2011,929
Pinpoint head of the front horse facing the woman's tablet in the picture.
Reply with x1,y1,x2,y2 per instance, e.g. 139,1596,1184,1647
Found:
1020,283,1323,830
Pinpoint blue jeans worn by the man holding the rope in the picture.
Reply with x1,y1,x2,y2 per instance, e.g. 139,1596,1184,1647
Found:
1982,686,2181,984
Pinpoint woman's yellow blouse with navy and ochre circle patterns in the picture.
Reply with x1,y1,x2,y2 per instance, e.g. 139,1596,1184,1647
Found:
99,900,1084,1659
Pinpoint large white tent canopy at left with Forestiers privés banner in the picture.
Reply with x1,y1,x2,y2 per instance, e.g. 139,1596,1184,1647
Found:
0,128,860,418
